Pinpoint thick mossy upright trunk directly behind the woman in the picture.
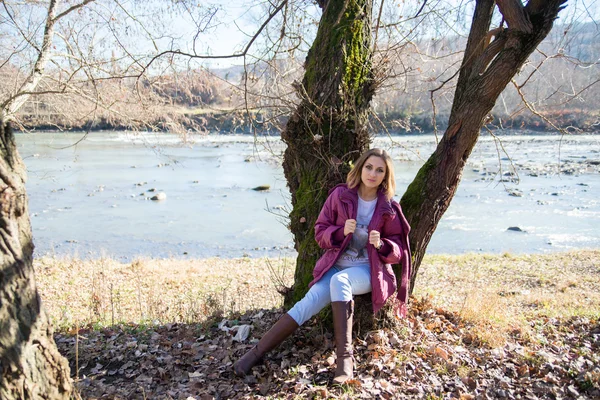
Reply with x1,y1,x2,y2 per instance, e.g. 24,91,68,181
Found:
281,0,374,306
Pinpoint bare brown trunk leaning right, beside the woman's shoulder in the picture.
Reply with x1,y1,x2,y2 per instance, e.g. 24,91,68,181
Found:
401,0,565,292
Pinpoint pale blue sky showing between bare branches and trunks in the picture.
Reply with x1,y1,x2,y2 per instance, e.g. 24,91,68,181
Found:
0,0,600,72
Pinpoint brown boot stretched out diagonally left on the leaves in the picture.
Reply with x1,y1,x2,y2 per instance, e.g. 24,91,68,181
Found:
233,313,298,377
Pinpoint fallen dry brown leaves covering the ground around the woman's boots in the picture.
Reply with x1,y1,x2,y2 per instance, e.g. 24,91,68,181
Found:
55,299,600,399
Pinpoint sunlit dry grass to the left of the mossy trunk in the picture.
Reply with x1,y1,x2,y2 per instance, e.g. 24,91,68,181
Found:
34,257,293,330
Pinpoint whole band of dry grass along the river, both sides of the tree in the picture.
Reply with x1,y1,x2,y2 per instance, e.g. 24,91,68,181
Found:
35,250,600,345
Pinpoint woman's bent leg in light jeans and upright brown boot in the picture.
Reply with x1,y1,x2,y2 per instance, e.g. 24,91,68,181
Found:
330,265,371,383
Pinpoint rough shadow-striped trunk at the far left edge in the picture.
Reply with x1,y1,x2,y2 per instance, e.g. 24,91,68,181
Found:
0,119,72,399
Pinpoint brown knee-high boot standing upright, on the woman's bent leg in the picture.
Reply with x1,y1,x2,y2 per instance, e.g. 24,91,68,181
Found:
331,301,354,384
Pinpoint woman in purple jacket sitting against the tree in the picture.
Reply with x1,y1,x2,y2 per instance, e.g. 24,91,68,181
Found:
234,149,410,383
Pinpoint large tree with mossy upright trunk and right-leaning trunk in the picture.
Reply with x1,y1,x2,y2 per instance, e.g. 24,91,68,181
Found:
282,0,565,304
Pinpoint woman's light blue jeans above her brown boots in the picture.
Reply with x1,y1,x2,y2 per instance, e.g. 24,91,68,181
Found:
288,265,371,325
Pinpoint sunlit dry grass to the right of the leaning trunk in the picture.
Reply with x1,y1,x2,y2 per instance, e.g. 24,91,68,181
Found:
414,250,600,346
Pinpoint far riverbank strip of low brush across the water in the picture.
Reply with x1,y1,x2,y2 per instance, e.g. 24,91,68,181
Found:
15,108,600,134
